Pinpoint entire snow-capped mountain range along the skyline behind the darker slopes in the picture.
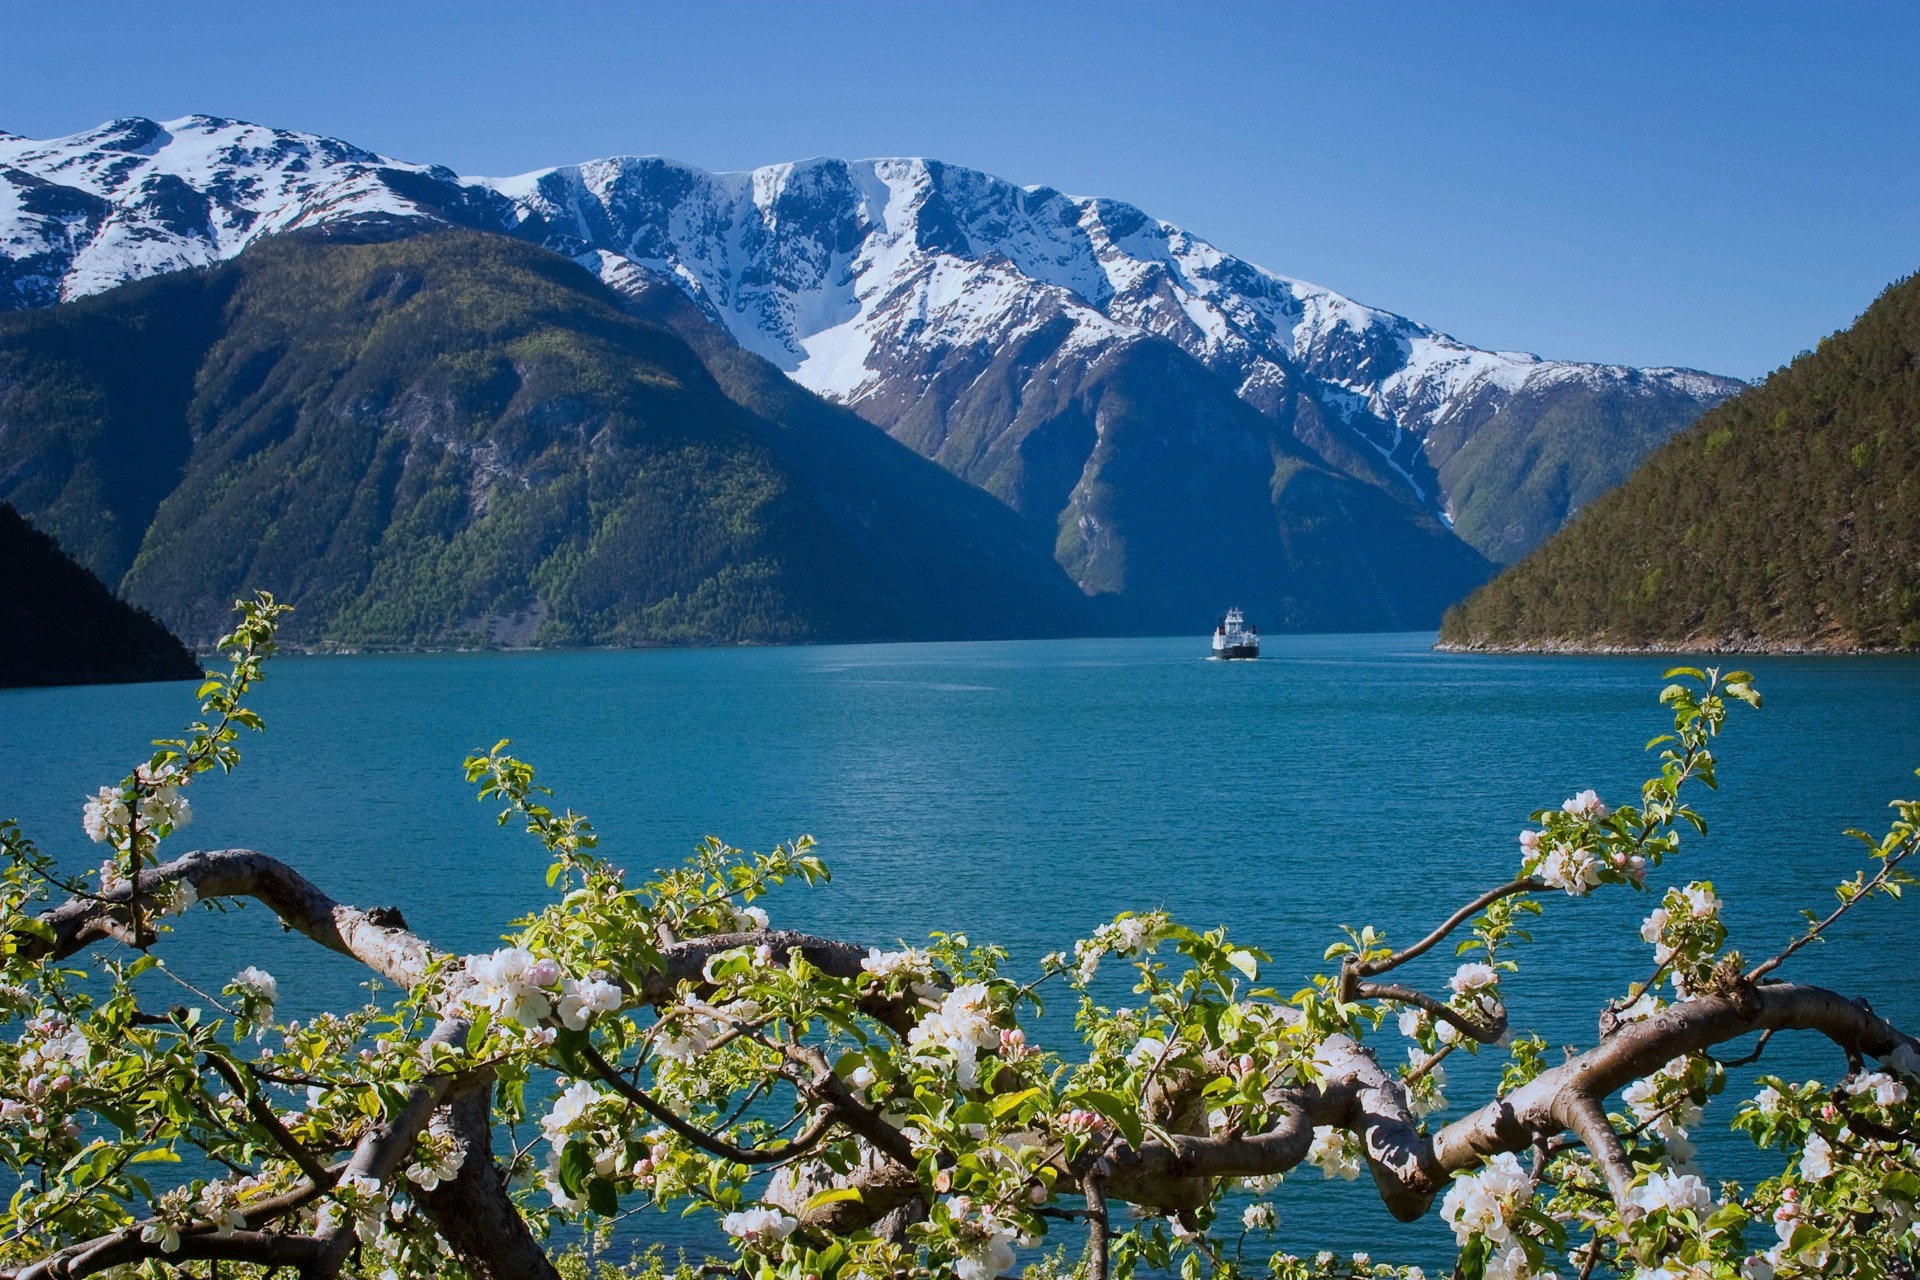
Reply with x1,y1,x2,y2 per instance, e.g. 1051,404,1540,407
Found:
0,115,1741,558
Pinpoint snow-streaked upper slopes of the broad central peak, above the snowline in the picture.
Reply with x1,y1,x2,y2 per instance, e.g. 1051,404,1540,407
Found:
484,157,1740,506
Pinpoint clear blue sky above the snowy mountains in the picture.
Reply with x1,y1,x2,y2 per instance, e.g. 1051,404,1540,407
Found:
0,0,1920,376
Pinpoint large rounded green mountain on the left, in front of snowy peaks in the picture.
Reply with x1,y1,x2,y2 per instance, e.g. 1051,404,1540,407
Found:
0,232,1092,647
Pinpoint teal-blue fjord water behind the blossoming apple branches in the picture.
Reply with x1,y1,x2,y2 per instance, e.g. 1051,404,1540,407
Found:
0,635,1920,1261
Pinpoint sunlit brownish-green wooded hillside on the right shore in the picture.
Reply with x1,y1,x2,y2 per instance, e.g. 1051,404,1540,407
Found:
1440,276,1920,649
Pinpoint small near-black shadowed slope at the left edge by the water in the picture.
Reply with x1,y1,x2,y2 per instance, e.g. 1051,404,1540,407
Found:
0,503,204,687
